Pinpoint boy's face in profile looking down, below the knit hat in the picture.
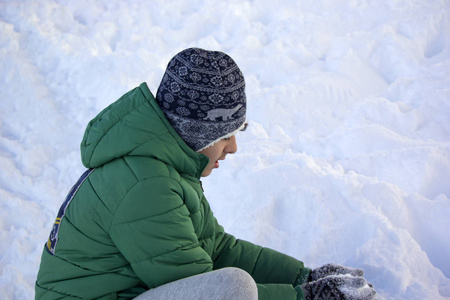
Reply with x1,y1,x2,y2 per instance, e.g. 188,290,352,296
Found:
199,135,237,177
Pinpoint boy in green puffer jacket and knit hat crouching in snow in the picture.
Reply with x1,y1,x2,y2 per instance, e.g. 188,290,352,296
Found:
36,48,375,299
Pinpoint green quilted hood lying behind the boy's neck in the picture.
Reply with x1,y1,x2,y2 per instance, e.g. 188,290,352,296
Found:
81,82,208,178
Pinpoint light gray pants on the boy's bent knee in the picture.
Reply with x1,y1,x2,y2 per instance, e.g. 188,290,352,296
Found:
134,268,258,300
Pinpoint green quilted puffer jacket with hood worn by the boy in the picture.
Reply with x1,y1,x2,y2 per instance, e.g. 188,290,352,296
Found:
36,83,309,299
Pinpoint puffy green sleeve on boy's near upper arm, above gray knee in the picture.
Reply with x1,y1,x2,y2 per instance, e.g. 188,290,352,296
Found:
110,178,213,288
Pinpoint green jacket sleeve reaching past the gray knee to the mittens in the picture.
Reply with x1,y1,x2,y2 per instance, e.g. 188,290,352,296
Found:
212,219,310,299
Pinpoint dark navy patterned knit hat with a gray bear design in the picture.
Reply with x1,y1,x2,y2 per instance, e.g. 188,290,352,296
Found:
156,48,246,151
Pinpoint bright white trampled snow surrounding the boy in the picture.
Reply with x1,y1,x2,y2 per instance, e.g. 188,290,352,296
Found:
0,0,450,299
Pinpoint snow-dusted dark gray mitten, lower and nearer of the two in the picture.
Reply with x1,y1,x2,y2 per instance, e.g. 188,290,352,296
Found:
301,275,377,300
